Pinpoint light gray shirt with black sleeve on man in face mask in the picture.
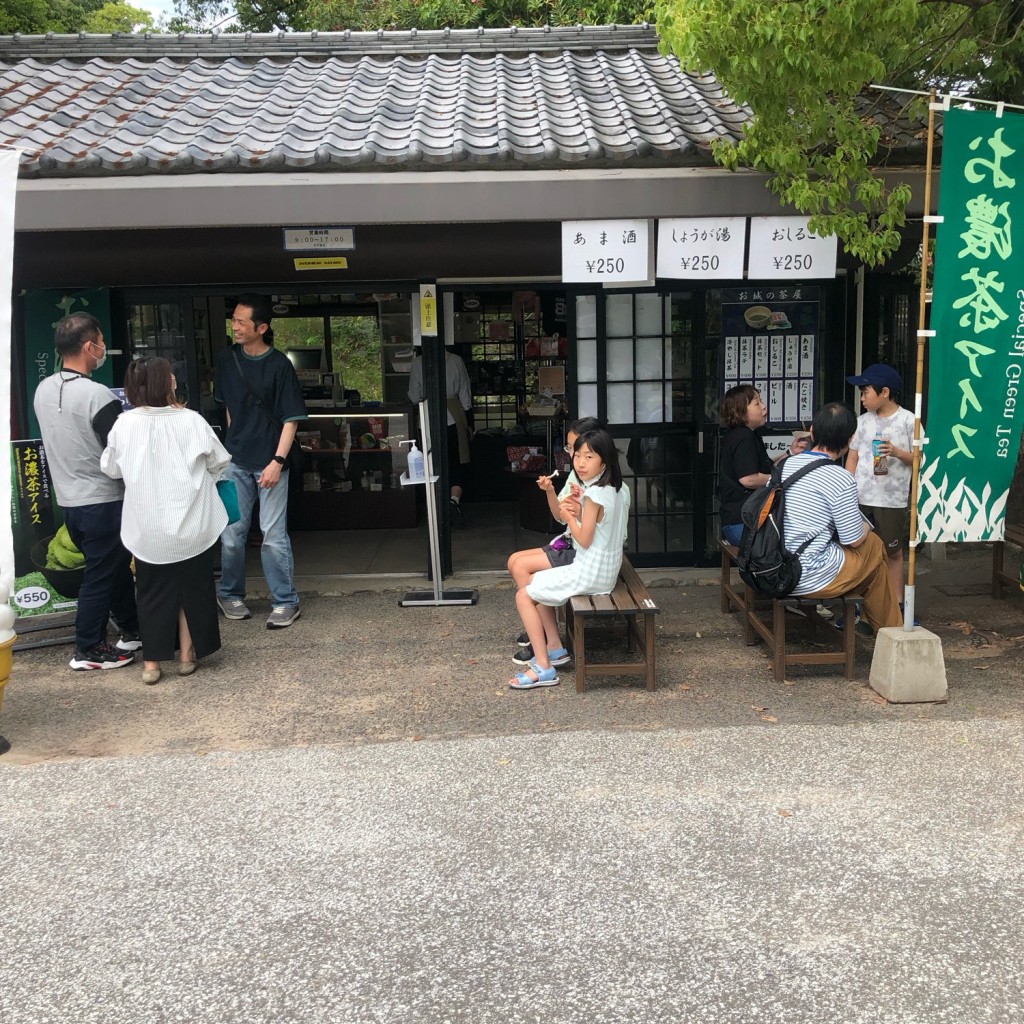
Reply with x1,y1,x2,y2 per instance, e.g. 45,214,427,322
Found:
32,370,124,508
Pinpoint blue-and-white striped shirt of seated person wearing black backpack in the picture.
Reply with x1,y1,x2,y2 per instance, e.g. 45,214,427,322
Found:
782,452,864,595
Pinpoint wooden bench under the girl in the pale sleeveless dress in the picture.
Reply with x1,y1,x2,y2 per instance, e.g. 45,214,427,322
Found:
565,555,660,693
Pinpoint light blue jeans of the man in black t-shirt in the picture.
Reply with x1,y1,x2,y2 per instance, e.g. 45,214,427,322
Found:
220,462,299,607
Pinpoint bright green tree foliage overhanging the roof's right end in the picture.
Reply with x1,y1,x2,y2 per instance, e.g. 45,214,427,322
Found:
657,0,1024,265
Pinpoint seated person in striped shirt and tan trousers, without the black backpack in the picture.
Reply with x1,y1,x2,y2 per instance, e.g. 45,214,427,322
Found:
782,401,903,631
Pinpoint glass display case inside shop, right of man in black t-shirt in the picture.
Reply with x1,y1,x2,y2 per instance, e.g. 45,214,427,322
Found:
289,406,417,529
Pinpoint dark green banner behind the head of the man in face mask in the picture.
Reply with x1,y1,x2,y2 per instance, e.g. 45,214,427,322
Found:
23,288,115,437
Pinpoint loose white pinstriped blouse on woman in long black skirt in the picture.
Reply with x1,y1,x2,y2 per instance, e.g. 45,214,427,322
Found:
100,407,231,565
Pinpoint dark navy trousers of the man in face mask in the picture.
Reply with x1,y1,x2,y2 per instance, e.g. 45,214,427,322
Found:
63,502,138,652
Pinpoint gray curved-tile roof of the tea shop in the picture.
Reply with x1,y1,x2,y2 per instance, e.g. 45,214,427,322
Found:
0,27,750,177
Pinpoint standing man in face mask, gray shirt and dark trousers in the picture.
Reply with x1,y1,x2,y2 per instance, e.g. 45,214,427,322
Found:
33,313,141,670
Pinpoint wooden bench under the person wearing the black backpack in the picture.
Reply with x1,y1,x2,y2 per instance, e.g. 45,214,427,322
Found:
718,540,863,683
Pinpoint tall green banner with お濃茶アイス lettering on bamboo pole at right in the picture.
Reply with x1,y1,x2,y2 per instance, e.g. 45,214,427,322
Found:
918,110,1024,542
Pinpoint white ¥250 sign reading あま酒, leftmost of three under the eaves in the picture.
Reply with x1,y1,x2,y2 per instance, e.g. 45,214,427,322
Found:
562,220,654,285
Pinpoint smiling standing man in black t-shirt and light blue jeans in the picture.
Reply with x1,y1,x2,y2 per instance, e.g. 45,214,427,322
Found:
214,295,306,630
